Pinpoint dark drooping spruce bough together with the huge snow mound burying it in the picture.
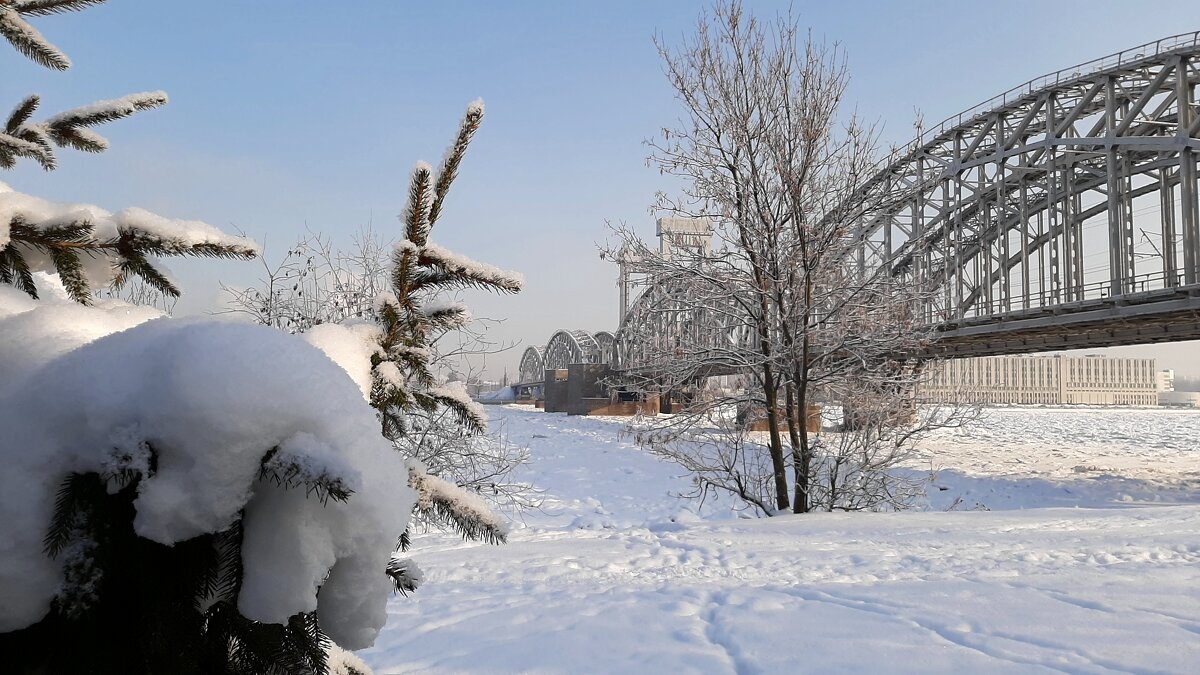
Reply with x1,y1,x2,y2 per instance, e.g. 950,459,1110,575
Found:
0,312,414,667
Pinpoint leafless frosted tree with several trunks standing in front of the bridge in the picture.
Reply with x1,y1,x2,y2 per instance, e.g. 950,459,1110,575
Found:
611,1,974,513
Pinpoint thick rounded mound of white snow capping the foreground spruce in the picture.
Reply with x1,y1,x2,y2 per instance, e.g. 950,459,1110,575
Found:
0,305,415,649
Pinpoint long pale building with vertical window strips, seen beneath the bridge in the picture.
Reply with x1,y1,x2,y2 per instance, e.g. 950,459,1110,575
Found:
920,354,1159,406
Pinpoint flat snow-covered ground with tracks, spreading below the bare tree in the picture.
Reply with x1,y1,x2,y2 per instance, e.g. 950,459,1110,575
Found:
360,407,1200,674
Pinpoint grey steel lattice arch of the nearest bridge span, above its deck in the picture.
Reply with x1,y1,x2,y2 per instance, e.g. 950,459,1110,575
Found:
853,34,1200,333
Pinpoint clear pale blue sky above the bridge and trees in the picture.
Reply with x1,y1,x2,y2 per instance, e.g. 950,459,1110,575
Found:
7,0,1200,376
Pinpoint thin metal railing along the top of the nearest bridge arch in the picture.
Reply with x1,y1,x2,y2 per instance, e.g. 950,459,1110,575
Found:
882,31,1200,166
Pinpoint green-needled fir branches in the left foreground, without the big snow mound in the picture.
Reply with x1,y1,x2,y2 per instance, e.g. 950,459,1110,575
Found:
0,0,521,674
